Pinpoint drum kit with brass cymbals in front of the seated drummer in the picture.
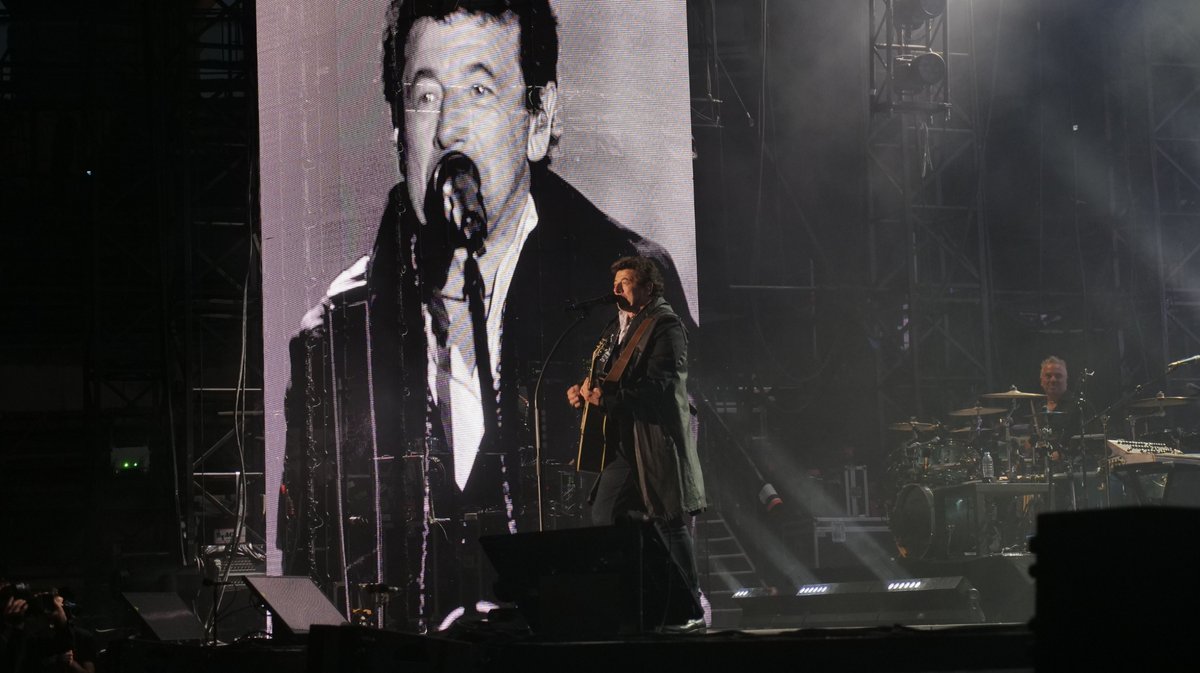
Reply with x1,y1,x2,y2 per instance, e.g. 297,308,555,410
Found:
886,386,1200,558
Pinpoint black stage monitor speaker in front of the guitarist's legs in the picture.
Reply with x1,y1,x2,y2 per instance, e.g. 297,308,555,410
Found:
479,522,701,637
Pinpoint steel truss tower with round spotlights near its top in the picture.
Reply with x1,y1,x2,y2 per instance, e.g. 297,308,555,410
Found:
866,0,992,431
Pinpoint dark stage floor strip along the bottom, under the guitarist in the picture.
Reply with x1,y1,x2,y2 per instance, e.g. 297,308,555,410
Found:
108,624,1034,673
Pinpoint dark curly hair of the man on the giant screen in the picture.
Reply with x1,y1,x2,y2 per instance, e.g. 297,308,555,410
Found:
383,0,558,118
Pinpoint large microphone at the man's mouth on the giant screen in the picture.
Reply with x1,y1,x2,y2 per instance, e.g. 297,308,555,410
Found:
425,151,487,254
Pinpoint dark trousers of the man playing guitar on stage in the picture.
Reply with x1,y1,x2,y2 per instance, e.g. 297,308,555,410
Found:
592,455,700,609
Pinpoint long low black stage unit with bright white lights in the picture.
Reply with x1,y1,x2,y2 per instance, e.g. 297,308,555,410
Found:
733,576,984,629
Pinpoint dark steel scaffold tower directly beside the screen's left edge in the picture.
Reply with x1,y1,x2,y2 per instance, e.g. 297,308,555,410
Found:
170,0,265,572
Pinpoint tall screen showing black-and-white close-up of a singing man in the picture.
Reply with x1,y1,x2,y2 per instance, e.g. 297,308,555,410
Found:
258,0,698,630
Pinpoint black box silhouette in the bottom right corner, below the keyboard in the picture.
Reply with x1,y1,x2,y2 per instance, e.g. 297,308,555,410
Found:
1032,506,1200,671
